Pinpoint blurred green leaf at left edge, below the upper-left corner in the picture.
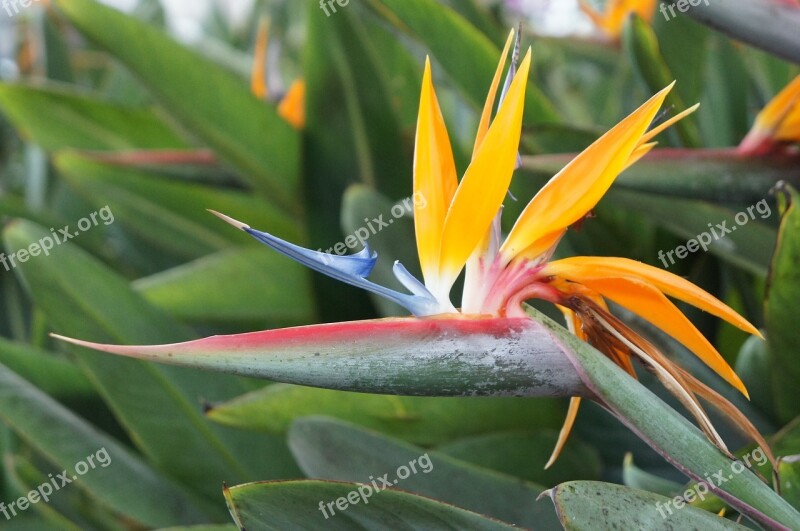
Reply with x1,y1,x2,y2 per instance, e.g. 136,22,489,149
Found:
0,84,188,151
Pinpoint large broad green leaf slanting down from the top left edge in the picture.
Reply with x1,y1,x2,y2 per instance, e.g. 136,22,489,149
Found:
57,0,299,211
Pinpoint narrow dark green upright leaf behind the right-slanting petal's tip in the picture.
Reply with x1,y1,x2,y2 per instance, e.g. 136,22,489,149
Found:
623,15,700,148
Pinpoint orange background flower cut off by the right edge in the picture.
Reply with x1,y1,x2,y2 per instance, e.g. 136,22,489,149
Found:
738,76,800,155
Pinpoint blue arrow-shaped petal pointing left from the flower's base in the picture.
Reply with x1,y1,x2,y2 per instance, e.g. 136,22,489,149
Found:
245,226,442,317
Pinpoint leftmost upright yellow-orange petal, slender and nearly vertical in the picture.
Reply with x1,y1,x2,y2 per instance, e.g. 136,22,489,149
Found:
414,59,458,291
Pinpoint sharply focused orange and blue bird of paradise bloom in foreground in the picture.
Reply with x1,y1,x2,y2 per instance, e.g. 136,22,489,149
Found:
55,31,774,466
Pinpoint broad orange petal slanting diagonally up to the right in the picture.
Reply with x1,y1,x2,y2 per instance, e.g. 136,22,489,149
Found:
500,83,674,261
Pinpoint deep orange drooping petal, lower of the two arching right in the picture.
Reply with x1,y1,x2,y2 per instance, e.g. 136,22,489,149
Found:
556,277,748,396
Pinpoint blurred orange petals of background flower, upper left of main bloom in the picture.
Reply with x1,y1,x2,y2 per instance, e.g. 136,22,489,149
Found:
250,19,306,129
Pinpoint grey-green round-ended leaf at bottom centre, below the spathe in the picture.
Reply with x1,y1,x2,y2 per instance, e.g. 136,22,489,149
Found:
289,417,557,529
